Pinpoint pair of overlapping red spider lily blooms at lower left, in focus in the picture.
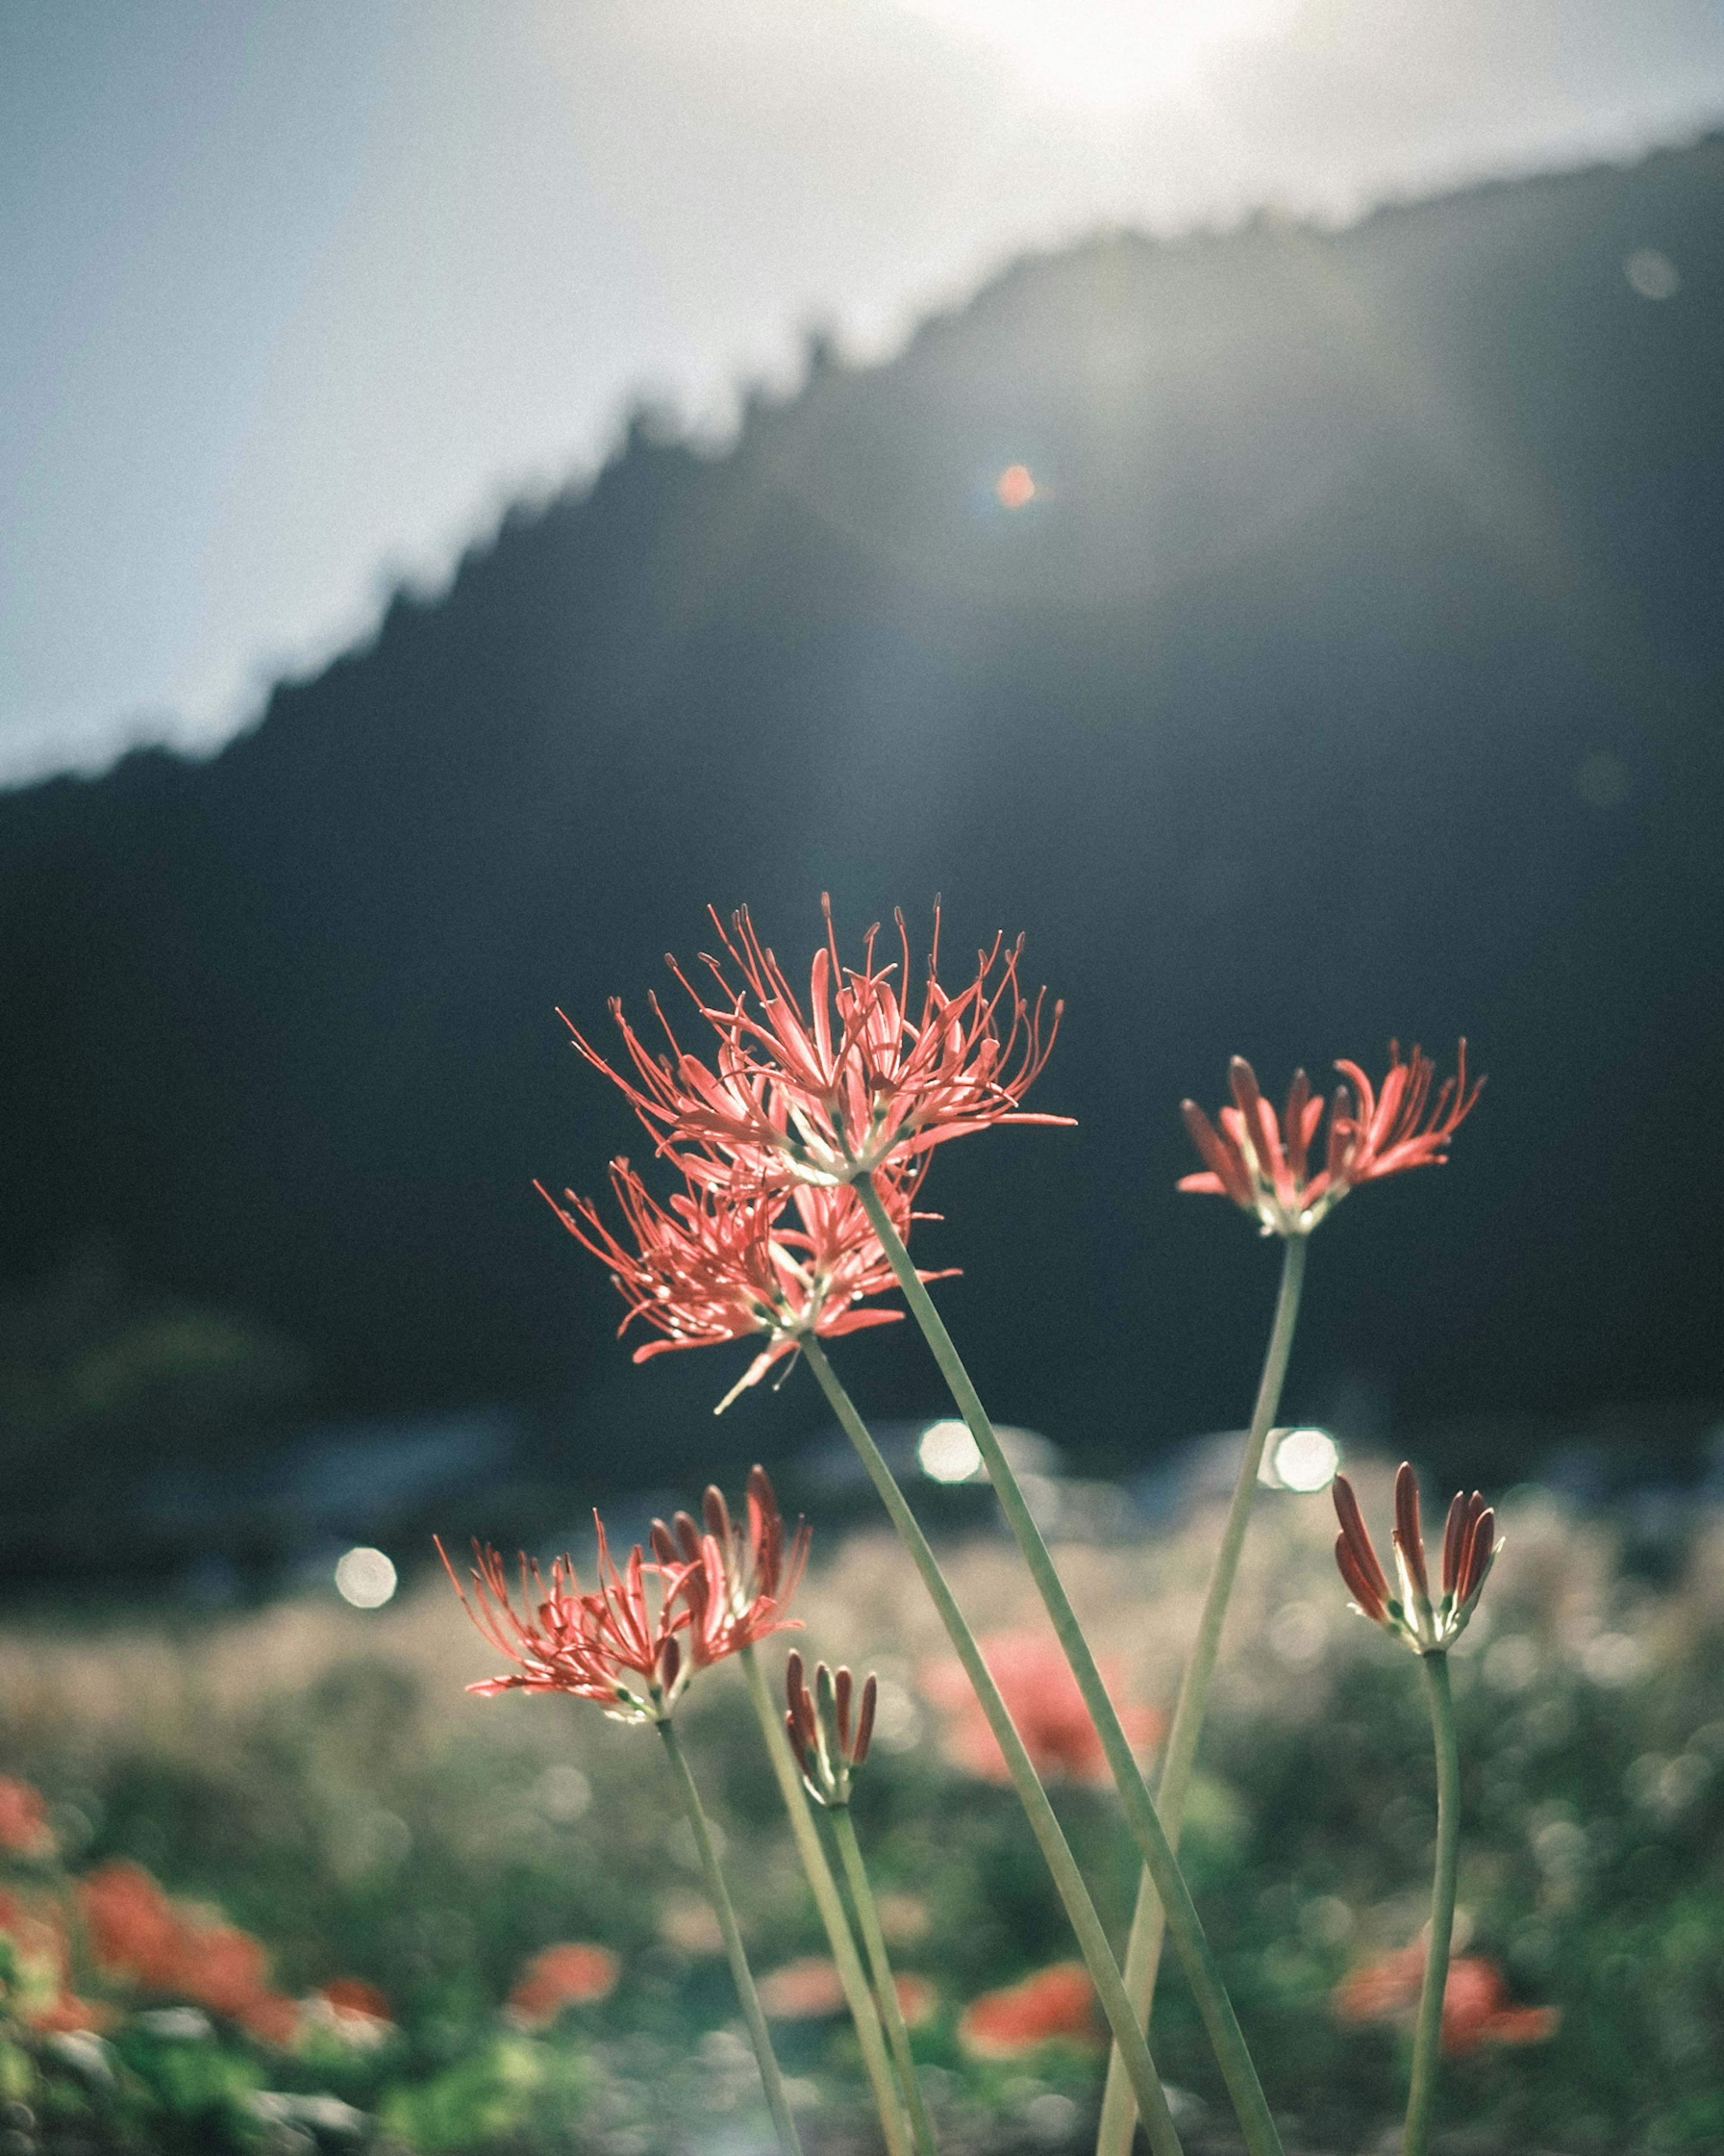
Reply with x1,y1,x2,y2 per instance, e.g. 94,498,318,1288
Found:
450,1468,808,1723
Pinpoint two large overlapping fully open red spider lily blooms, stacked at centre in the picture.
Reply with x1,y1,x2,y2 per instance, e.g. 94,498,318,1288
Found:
550,905,1067,1412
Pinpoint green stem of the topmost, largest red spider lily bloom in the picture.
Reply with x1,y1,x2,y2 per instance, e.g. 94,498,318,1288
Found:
853,1175,1282,2156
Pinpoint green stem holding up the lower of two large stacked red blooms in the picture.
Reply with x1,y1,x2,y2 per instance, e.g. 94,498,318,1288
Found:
802,1332,1181,2156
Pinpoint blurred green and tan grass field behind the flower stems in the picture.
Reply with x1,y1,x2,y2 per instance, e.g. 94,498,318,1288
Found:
0,1470,1724,2156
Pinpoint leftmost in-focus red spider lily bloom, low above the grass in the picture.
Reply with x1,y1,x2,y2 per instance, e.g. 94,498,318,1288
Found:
437,1513,690,1723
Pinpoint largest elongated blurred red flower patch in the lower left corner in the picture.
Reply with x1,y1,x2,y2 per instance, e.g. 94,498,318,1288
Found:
78,1858,299,2044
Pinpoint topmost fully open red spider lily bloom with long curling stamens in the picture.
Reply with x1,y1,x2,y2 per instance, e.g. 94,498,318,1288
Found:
565,899,1071,1184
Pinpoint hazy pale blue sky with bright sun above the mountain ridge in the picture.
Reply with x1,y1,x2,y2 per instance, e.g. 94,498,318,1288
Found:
0,0,1724,783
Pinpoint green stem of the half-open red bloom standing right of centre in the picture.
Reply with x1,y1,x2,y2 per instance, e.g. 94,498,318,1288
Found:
1095,1235,1306,2156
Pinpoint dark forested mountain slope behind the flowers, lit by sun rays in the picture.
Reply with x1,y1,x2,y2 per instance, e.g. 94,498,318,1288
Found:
0,138,1724,1535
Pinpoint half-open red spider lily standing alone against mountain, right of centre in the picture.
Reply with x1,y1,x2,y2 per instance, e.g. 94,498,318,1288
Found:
1179,1041,1485,1235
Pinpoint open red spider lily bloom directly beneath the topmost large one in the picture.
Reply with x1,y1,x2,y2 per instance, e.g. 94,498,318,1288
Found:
539,1160,942,1414
